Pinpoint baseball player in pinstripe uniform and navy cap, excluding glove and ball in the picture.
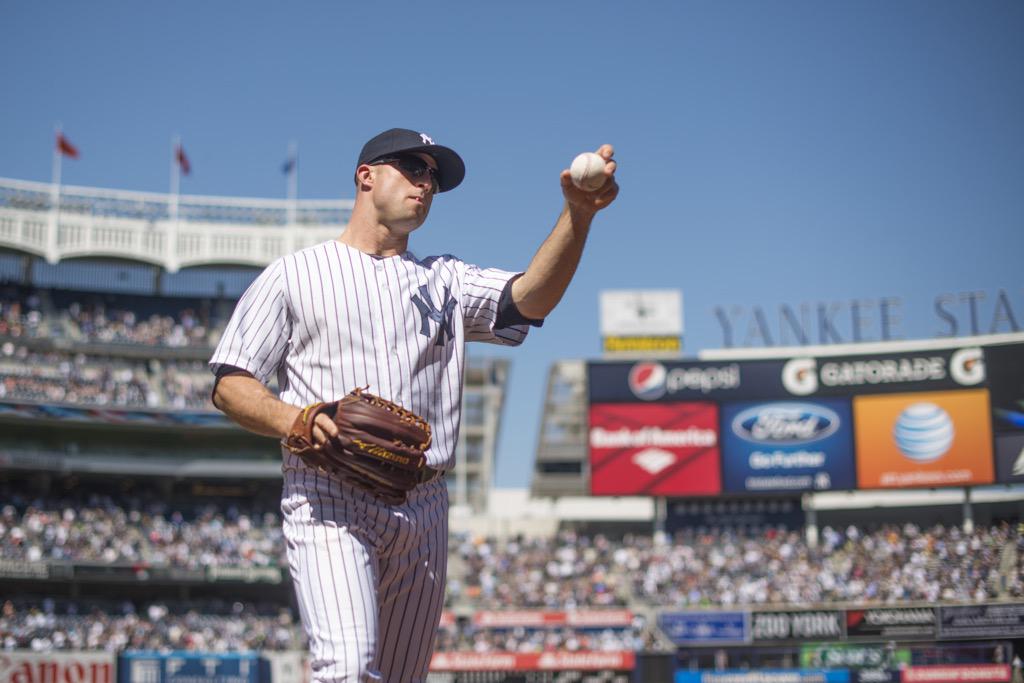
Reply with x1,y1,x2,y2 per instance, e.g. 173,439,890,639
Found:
203,128,618,683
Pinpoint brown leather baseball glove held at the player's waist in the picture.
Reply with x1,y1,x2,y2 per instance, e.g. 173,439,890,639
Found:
283,388,430,505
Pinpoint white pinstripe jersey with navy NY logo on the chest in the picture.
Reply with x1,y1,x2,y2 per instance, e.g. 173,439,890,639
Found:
210,241,528,469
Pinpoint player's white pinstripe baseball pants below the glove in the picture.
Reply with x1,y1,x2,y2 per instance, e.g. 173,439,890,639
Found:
281,471,447,683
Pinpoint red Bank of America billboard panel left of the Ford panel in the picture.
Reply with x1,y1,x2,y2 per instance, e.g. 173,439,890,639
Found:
590,401,722,496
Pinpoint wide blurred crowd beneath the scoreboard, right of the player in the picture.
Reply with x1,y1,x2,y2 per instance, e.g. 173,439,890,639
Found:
450,524,1024,609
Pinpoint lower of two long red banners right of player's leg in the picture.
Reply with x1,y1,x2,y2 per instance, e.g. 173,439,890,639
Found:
430,651,636,680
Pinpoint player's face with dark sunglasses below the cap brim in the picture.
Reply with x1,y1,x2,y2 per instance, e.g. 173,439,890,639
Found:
372,155,436,232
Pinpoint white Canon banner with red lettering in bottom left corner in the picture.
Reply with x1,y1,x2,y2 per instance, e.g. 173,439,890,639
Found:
0,650,115,683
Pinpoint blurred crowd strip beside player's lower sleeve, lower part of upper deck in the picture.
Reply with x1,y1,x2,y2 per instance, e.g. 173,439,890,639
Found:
0,341,213,410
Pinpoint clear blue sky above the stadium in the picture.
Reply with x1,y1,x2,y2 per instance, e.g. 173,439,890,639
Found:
0,0,1024,485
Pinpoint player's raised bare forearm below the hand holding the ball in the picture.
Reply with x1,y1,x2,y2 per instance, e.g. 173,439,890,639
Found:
512,205,594,319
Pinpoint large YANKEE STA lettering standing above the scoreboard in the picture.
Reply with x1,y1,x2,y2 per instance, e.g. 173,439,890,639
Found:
714,289,1024,348
